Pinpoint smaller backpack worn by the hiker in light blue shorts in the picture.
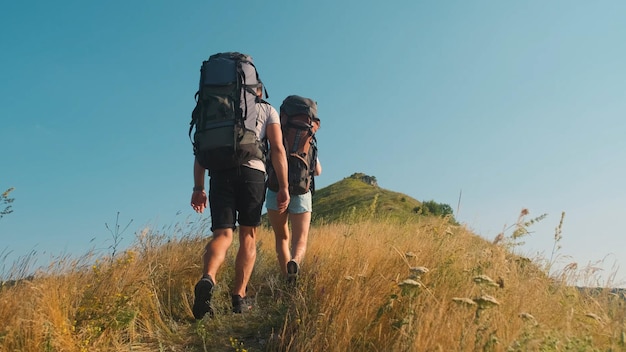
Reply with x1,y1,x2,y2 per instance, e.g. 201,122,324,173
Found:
267,95,320,195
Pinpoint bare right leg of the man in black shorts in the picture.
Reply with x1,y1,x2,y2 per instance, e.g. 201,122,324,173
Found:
233,226,256,297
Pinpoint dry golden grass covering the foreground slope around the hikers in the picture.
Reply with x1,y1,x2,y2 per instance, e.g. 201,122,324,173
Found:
0,214,626,352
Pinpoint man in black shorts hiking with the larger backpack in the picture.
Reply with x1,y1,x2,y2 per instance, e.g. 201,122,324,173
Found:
191,53,290,319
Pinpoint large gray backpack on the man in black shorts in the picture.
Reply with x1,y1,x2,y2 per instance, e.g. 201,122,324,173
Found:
189,52,267,171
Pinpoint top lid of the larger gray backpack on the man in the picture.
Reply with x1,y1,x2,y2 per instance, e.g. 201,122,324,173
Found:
200,52,260,87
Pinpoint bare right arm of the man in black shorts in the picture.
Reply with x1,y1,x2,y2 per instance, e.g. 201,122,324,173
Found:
266,123,289,213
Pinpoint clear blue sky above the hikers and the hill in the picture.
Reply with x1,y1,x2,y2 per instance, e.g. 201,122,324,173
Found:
0,0,626,283
